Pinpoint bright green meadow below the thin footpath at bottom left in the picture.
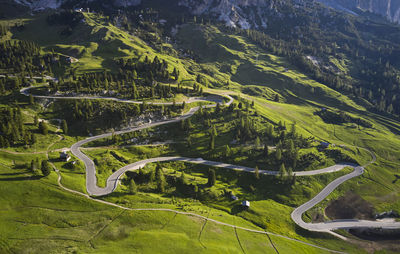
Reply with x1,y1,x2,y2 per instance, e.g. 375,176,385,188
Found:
0,161,320,253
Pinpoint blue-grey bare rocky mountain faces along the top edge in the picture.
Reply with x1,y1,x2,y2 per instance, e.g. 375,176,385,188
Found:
8,0,400,25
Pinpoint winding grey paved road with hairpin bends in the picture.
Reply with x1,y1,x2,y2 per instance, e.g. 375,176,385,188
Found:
21,84,400,242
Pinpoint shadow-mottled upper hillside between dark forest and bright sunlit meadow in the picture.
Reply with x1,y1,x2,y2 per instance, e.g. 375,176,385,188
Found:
177,25,368,109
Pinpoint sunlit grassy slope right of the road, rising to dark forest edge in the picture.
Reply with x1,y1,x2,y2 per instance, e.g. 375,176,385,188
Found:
178,20,400,226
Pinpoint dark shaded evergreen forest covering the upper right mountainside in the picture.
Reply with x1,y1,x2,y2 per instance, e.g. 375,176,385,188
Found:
200,1,400,115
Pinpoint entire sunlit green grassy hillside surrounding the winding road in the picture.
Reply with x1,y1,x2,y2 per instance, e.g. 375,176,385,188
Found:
0,8,400,253
